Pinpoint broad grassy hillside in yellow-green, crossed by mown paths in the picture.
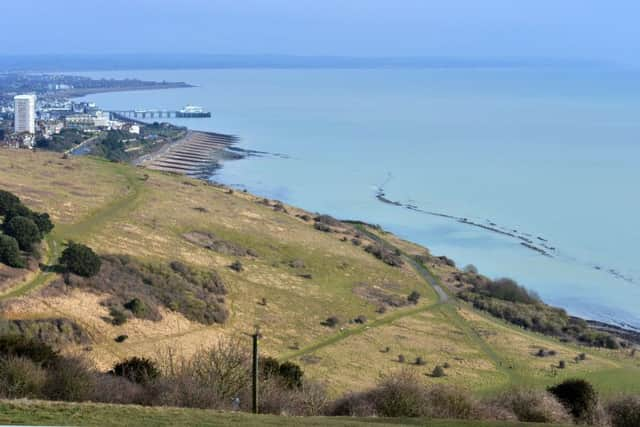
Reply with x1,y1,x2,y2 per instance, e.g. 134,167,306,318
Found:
0,150,640,398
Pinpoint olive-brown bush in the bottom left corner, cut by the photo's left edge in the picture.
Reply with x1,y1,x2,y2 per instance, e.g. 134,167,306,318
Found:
0,356,47,399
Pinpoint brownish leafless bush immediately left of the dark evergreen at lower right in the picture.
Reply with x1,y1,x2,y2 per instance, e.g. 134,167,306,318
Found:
494,389,571,424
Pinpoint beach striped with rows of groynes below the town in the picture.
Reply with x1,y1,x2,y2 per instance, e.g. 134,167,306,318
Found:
140,131,236,177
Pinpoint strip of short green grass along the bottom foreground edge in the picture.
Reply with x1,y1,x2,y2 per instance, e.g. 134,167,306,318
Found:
0,400,568,427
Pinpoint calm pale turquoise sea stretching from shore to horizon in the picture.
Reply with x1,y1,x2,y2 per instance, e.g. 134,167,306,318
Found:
77,69,640,328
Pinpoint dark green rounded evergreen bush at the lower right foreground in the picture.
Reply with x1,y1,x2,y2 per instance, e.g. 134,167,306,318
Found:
549,379,598,422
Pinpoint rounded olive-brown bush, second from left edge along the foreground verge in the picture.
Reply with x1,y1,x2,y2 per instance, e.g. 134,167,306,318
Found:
44,357,96,402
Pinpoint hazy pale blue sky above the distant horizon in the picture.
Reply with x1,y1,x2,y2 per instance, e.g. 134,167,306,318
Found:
5,0,640,64
